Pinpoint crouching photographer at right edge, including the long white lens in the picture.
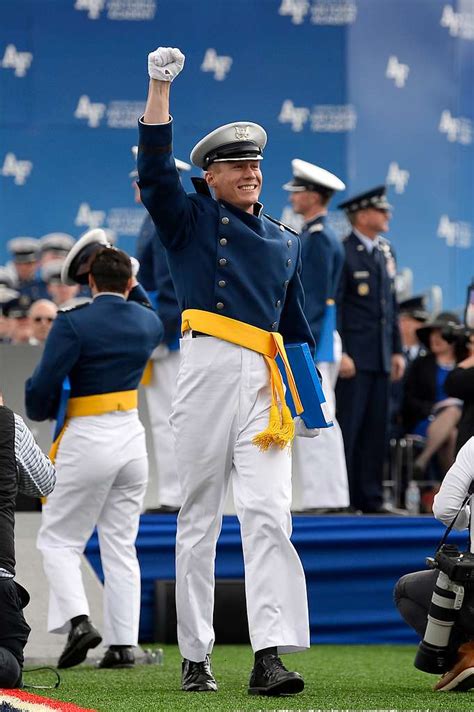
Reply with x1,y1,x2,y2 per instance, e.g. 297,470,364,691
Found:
394,437,474,691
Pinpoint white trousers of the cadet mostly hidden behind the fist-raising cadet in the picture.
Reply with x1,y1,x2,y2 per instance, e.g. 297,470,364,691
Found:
145,347,181,509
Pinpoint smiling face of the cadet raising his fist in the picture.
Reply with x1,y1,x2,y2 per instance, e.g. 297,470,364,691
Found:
205,161,262,213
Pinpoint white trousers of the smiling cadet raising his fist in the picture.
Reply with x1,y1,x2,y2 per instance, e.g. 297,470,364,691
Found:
171,334,309,661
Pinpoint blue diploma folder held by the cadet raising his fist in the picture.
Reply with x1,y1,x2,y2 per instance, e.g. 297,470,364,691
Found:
277,344,333,428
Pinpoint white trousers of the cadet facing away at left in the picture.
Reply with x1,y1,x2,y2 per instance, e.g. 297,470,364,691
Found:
37,410,148,645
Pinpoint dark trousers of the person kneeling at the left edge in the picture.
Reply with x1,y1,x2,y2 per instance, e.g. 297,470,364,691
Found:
0,578,31,688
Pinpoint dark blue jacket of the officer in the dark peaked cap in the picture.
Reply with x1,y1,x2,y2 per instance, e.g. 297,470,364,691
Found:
337,232,402,373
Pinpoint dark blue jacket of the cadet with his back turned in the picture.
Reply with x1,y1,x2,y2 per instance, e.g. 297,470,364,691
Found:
26,287,163,420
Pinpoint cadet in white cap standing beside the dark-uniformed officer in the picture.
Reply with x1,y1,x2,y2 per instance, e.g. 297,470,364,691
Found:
283,158,349,513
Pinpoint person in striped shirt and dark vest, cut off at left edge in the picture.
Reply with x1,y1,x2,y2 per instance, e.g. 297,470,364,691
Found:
0,393,56,688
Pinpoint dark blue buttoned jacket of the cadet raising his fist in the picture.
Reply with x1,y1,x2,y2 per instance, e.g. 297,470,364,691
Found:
138,121,314,349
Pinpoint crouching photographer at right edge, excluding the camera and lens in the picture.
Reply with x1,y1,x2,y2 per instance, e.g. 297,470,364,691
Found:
394,437,474,692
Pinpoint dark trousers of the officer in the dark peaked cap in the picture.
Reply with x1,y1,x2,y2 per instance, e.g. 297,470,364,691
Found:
336,371,390,512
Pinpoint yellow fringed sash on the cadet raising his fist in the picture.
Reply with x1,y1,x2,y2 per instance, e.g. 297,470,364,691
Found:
181,309,303,450
